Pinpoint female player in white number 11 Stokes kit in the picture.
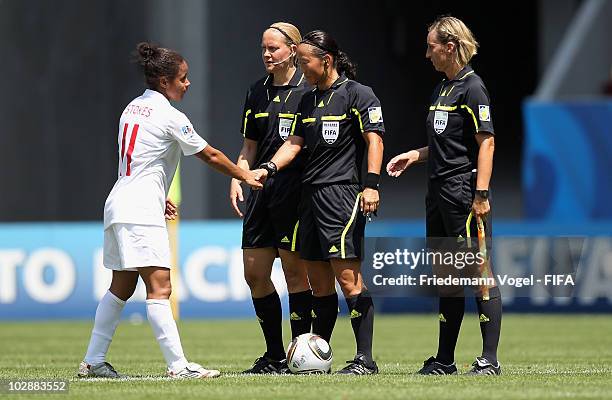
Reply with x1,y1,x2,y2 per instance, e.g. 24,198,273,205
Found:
78,43,262,378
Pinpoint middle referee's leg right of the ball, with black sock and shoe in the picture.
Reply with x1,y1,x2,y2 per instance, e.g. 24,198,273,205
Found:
331,258,378,375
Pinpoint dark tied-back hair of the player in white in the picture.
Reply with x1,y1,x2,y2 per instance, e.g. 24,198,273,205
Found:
136,42,185,89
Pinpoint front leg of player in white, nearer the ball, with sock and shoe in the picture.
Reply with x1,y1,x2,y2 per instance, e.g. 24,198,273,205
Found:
138,267,220,378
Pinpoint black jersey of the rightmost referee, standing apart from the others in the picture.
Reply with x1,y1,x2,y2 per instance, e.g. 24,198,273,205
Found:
427,65,494,179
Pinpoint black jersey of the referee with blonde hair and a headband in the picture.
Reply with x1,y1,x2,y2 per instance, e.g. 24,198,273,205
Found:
240,69,312,169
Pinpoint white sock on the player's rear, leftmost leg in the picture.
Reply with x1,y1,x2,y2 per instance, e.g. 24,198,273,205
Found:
85,291,125,365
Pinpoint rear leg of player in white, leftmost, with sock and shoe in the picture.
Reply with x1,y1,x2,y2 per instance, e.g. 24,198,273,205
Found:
78,271,138,378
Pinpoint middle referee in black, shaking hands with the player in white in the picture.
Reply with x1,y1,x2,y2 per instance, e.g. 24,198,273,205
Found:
262,31,385,375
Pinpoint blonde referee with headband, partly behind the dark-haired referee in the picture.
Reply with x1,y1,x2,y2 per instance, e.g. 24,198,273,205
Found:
230,22,312,374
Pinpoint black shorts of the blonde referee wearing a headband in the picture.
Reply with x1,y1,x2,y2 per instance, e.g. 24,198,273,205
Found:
242,169,302,251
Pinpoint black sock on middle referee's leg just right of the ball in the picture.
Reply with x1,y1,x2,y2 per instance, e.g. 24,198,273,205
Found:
346,290,374,362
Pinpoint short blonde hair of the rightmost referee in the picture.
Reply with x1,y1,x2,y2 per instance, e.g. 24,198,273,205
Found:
428,16,478,67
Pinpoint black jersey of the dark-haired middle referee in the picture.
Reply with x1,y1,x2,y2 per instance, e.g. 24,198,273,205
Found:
294,74,385,185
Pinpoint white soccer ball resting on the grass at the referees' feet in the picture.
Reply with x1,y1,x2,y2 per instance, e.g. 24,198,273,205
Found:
287,333,333,374
